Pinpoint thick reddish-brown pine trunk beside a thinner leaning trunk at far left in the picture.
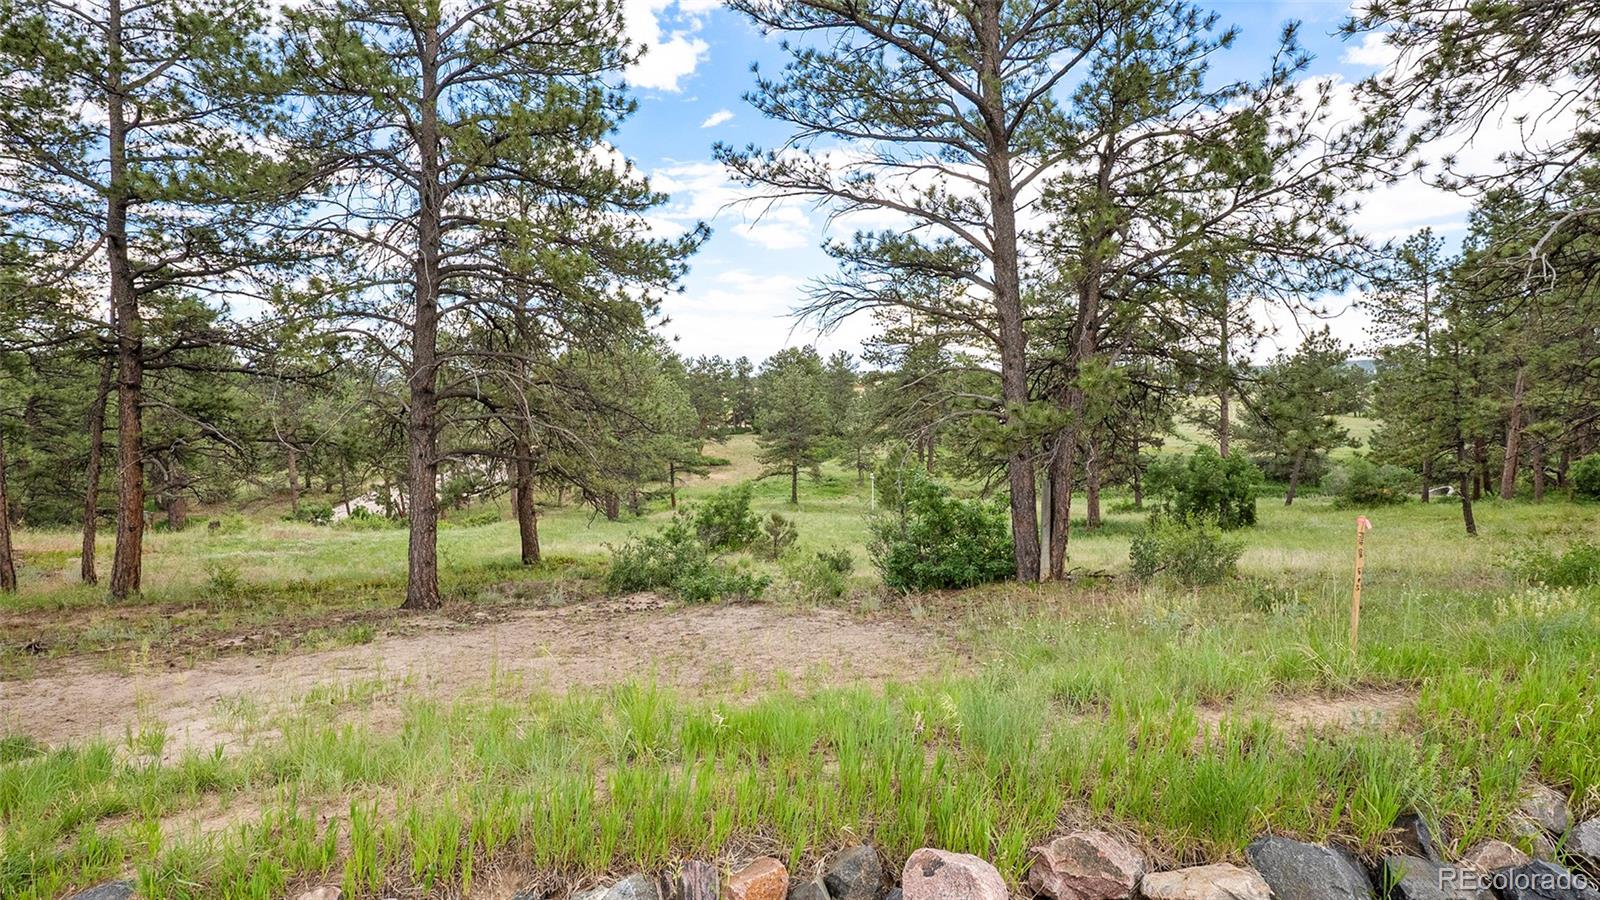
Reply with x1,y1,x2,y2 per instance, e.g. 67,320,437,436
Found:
106,8,144,601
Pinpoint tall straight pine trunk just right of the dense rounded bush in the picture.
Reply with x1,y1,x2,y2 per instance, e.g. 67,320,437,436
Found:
976,0,1038,581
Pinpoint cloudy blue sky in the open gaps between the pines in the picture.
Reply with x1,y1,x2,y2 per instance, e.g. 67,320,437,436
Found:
616,0,1488,360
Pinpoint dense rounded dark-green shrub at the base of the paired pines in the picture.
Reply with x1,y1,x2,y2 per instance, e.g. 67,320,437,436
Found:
870,468,1016,591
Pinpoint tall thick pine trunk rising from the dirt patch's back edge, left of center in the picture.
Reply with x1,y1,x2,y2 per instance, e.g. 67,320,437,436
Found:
402,13,443,610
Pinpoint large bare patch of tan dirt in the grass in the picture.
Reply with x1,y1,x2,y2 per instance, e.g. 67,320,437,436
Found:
0,594,954,756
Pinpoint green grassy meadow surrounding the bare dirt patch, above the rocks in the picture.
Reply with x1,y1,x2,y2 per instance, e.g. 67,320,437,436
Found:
0,437,1600,900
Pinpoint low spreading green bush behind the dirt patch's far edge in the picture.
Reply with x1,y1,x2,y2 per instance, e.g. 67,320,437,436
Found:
606,512,768,602
